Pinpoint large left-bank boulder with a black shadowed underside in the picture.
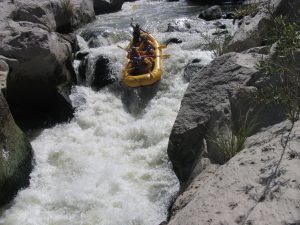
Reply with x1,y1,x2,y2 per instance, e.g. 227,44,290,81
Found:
0,21,76,128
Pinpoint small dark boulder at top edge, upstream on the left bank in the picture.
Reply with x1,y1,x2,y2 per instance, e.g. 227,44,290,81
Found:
94,0,125,15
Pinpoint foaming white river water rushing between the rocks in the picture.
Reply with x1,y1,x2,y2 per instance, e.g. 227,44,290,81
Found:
0,1,234,225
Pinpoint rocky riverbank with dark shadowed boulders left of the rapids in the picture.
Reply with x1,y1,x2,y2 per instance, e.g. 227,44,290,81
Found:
0,0,124,205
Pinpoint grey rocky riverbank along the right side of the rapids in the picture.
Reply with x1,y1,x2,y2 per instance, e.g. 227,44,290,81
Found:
168,0,300,225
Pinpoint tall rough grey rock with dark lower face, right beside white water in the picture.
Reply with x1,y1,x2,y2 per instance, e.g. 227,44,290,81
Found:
168,53,258,183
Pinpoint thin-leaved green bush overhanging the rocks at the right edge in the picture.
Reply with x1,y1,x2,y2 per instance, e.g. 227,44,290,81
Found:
256,16,300,121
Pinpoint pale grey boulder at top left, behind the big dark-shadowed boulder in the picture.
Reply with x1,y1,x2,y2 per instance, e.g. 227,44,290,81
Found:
12,0,95,33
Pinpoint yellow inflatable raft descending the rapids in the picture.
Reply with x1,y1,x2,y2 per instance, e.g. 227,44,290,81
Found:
122,33,162,87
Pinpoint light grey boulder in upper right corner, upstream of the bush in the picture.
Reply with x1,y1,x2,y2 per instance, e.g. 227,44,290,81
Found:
228,0,300,52
